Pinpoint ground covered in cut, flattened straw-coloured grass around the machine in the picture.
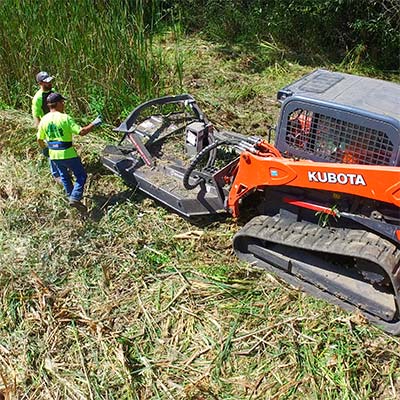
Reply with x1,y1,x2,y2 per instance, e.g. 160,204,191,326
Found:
0,35,400,400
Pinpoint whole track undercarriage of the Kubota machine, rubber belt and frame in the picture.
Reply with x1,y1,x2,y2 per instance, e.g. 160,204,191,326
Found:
234,215,400,334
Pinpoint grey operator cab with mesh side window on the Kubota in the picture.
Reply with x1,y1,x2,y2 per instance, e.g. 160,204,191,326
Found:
275,69,400,166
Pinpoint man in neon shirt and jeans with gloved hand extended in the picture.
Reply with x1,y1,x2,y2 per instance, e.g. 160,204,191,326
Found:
37,92,102,211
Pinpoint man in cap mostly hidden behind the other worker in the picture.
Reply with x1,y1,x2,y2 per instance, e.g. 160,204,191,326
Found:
32,71,61,183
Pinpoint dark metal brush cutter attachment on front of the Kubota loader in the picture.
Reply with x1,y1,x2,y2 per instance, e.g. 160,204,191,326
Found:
102,94,254,217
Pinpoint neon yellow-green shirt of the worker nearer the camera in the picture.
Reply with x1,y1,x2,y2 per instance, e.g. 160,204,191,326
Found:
37,111,81,160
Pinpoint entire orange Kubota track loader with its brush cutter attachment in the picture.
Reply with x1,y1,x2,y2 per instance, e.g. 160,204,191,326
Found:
102,70,400,334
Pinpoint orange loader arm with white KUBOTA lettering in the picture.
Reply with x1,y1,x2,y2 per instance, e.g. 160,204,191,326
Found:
227,142,400,217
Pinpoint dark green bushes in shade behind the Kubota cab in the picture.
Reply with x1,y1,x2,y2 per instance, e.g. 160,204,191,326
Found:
180,0,400,70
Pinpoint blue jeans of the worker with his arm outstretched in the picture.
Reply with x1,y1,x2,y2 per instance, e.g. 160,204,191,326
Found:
52,157,87,200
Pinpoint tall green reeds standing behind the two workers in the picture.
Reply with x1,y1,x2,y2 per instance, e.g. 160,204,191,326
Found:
0,0,181,119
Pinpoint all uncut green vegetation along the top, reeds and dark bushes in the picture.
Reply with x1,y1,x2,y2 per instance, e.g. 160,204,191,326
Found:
0,0,400,125
